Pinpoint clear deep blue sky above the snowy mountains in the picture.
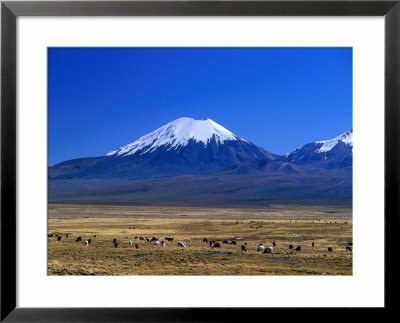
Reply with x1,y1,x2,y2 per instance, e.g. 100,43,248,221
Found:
48,48,352,165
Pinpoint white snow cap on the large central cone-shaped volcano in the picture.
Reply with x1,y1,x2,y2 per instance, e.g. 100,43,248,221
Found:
106,117,241,156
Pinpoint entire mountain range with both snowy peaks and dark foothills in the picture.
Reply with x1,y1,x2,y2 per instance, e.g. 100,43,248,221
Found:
48,118,353,200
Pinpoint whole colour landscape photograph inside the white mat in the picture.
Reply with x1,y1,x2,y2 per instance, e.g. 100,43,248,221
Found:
47,47,354,276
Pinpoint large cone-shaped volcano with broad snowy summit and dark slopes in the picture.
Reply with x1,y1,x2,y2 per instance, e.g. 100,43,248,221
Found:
49,118,277,179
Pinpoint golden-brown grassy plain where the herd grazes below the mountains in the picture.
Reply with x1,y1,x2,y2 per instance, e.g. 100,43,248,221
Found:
48,204,353,275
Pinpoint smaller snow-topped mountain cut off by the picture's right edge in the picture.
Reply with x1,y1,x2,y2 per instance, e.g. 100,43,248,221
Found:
284,130,353,168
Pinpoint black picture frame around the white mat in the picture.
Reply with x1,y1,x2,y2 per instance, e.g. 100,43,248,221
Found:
0,0,400,322
